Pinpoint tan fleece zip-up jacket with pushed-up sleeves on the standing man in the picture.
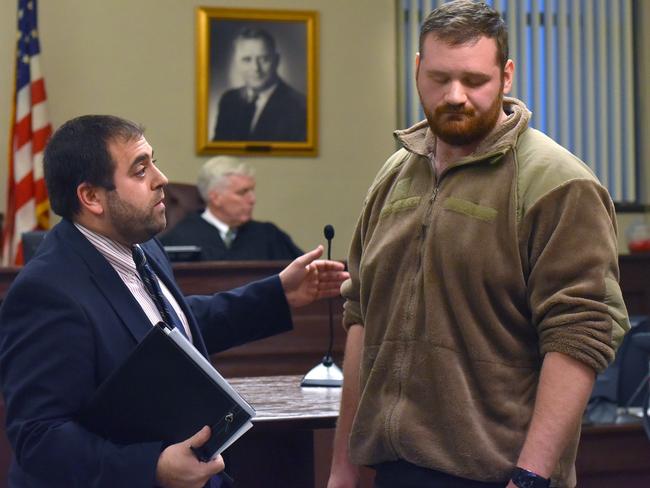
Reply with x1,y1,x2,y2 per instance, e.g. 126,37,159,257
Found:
342,98,629,486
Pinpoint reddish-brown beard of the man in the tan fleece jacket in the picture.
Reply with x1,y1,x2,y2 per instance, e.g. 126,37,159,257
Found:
422,91,503,146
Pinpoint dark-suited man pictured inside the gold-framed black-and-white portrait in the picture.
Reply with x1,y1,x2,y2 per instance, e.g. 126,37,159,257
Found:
213,28,307,141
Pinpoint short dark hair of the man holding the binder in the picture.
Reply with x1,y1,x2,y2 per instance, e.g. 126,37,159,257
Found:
43,115,144,219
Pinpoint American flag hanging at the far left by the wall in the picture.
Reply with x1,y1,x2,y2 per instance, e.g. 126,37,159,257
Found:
2,0,52,265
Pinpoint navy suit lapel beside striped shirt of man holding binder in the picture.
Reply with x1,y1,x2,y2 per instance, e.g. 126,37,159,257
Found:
56,220,151,342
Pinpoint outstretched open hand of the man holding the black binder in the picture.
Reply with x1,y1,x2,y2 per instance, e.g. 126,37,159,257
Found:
280,246,350,308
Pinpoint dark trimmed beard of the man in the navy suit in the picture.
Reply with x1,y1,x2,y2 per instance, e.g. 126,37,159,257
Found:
107,190,167,244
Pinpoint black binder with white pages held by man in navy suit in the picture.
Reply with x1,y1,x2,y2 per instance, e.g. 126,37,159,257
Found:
78,322,255,461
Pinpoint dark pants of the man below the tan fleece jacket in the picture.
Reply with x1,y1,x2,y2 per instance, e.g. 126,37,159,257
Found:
373,460,508,488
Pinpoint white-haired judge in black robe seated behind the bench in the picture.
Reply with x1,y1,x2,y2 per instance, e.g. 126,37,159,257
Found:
160,156,302,261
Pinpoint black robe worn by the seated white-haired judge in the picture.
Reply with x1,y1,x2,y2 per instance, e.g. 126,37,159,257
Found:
160,213,302,261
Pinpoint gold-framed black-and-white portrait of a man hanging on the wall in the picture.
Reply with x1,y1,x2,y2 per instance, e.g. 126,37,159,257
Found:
196,7,318,156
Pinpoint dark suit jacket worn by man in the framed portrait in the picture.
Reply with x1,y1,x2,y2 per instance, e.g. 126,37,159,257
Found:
213,80,307,141
